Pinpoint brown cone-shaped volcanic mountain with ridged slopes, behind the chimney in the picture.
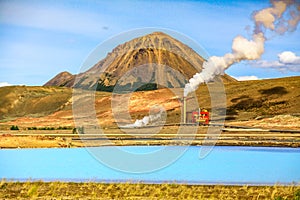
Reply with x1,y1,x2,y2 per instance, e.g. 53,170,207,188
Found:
45,32,236,91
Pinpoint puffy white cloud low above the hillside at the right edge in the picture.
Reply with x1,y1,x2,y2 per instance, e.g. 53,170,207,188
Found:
251,51,300,72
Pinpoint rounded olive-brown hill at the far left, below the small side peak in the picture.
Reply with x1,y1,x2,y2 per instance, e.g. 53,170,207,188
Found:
0,86,72,120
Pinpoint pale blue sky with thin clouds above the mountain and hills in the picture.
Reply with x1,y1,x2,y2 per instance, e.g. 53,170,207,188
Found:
0,0,300,86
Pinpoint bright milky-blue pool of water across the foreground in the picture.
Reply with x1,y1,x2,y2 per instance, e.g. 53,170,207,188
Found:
0,146,300,185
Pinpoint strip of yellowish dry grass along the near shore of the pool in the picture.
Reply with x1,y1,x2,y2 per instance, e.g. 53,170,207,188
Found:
0,180,300,200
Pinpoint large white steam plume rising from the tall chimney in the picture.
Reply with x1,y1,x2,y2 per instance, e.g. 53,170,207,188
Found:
184,0,300,96
